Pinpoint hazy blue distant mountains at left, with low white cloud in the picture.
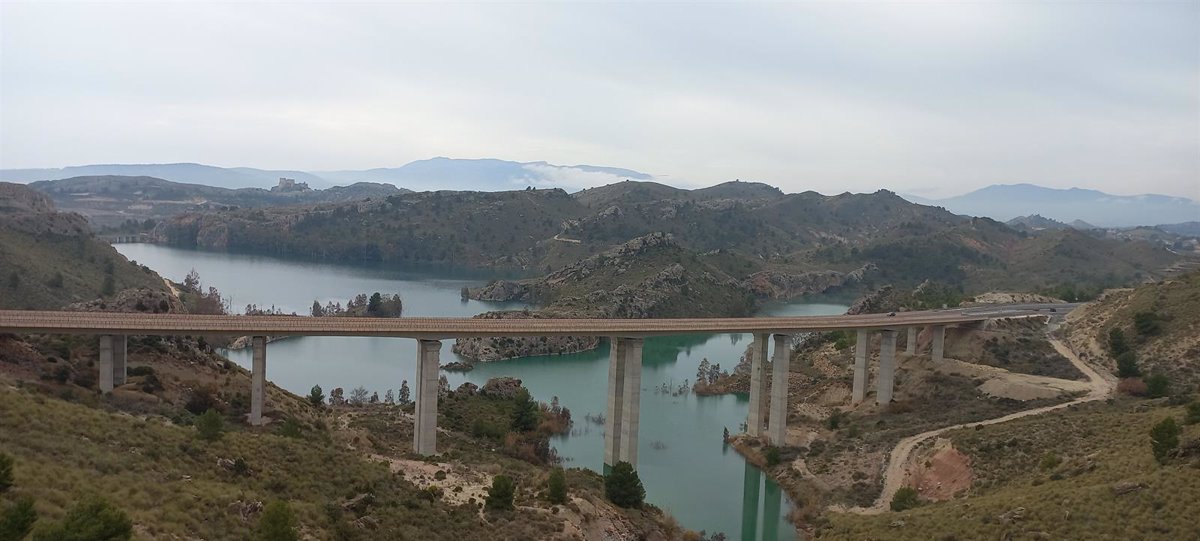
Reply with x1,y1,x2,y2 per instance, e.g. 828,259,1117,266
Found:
0,157,652,191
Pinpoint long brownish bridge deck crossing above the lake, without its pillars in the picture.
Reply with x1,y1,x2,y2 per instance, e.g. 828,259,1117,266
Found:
0,305,1072,339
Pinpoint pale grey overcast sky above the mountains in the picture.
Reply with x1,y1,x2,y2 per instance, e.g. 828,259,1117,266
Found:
0,0,1200,199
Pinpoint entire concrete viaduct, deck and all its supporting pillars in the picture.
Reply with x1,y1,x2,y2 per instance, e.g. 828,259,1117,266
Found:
0,305,1060,465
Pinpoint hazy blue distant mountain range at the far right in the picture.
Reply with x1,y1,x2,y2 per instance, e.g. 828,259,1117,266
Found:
904,184,1200,227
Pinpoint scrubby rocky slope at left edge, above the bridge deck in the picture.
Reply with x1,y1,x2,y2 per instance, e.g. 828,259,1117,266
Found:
0,182,167,309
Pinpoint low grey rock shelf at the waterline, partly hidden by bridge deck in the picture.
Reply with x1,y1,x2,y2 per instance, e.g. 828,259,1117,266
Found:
452,311,600,361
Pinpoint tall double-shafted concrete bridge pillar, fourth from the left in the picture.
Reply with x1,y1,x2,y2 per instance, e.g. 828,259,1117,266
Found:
604,337,642,468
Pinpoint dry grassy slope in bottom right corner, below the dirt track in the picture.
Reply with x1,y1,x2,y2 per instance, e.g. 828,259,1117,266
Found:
820,401,1200,540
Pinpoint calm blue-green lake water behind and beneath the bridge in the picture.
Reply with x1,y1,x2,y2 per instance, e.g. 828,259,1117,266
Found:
116,244,846,541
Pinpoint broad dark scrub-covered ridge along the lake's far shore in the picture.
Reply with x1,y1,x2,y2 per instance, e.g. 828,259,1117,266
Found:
156,181,1178,296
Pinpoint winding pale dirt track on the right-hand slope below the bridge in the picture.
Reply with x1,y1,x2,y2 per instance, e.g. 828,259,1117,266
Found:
849,337,1116,515
